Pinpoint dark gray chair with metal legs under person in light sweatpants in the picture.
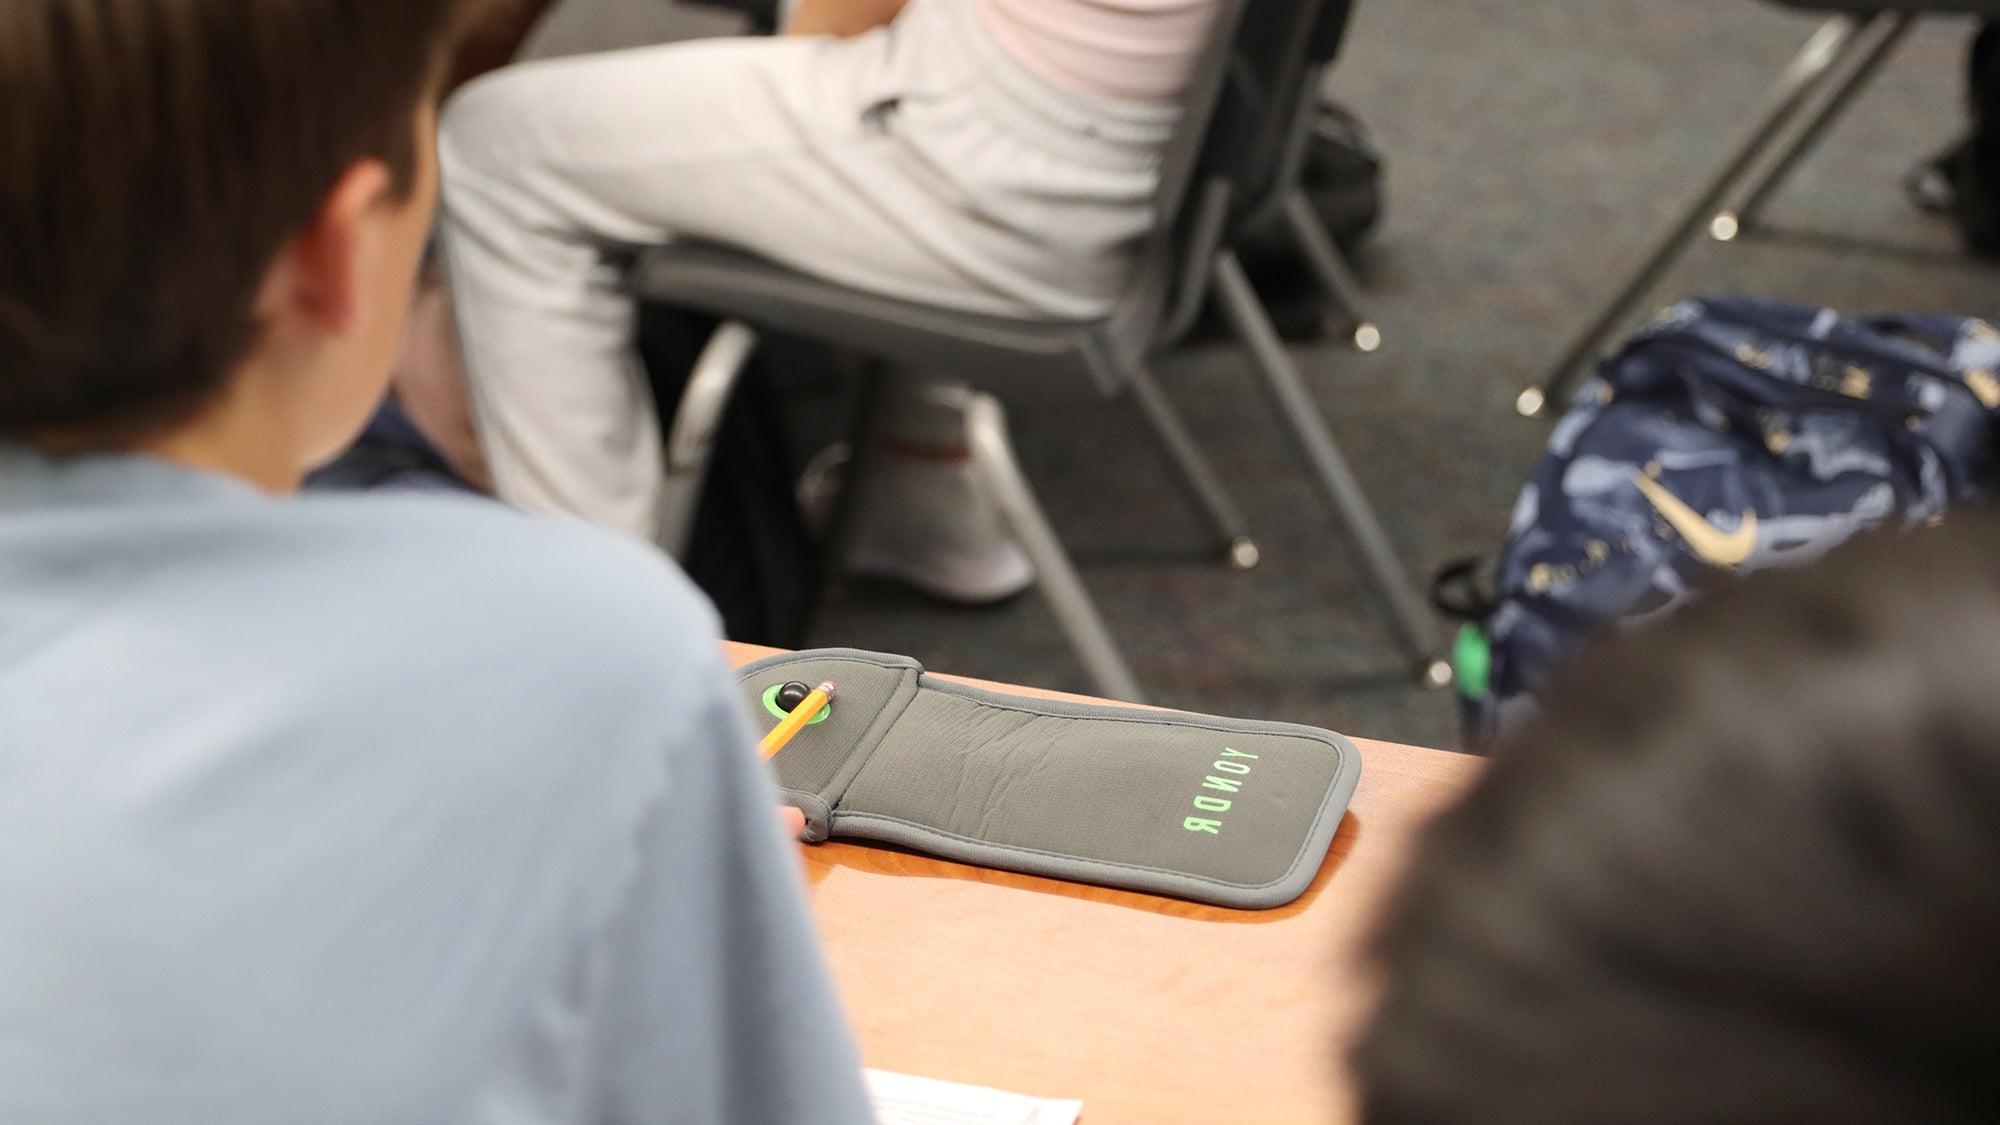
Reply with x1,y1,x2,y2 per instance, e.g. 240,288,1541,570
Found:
630,0,1442,699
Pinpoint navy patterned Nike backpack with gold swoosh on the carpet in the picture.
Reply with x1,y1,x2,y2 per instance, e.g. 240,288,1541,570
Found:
1440,296,2000,743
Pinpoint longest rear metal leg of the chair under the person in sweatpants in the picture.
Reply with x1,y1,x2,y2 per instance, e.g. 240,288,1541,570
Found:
1216,250,1452,687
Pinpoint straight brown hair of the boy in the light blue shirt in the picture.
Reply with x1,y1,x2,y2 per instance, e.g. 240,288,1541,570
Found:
0,0,458,438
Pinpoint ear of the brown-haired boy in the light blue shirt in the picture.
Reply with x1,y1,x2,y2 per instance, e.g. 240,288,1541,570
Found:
258,160,394,334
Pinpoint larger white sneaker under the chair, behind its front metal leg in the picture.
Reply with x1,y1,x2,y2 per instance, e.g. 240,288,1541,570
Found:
848,450,1034,605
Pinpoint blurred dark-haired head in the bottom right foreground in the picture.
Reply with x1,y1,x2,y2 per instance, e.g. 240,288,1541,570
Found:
1356,518,2000,1125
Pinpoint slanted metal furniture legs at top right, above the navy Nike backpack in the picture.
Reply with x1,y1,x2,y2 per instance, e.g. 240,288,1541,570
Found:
1514,0,2000,418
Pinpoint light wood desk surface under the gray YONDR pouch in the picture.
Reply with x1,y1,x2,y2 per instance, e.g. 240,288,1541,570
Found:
730,645,1478,1125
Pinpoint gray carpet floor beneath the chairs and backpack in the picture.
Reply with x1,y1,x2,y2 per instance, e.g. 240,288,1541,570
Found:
540,0,2000,747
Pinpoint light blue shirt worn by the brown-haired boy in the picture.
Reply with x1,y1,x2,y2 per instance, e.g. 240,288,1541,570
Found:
0,448,868,1125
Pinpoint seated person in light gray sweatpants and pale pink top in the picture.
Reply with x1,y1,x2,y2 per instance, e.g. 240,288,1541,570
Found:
444,0,1220,603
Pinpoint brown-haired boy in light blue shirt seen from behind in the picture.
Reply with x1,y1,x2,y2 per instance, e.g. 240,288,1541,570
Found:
0,0,868,1125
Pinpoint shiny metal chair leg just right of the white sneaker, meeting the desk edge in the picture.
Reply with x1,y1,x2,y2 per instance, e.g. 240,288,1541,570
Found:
966,394,1142,703
